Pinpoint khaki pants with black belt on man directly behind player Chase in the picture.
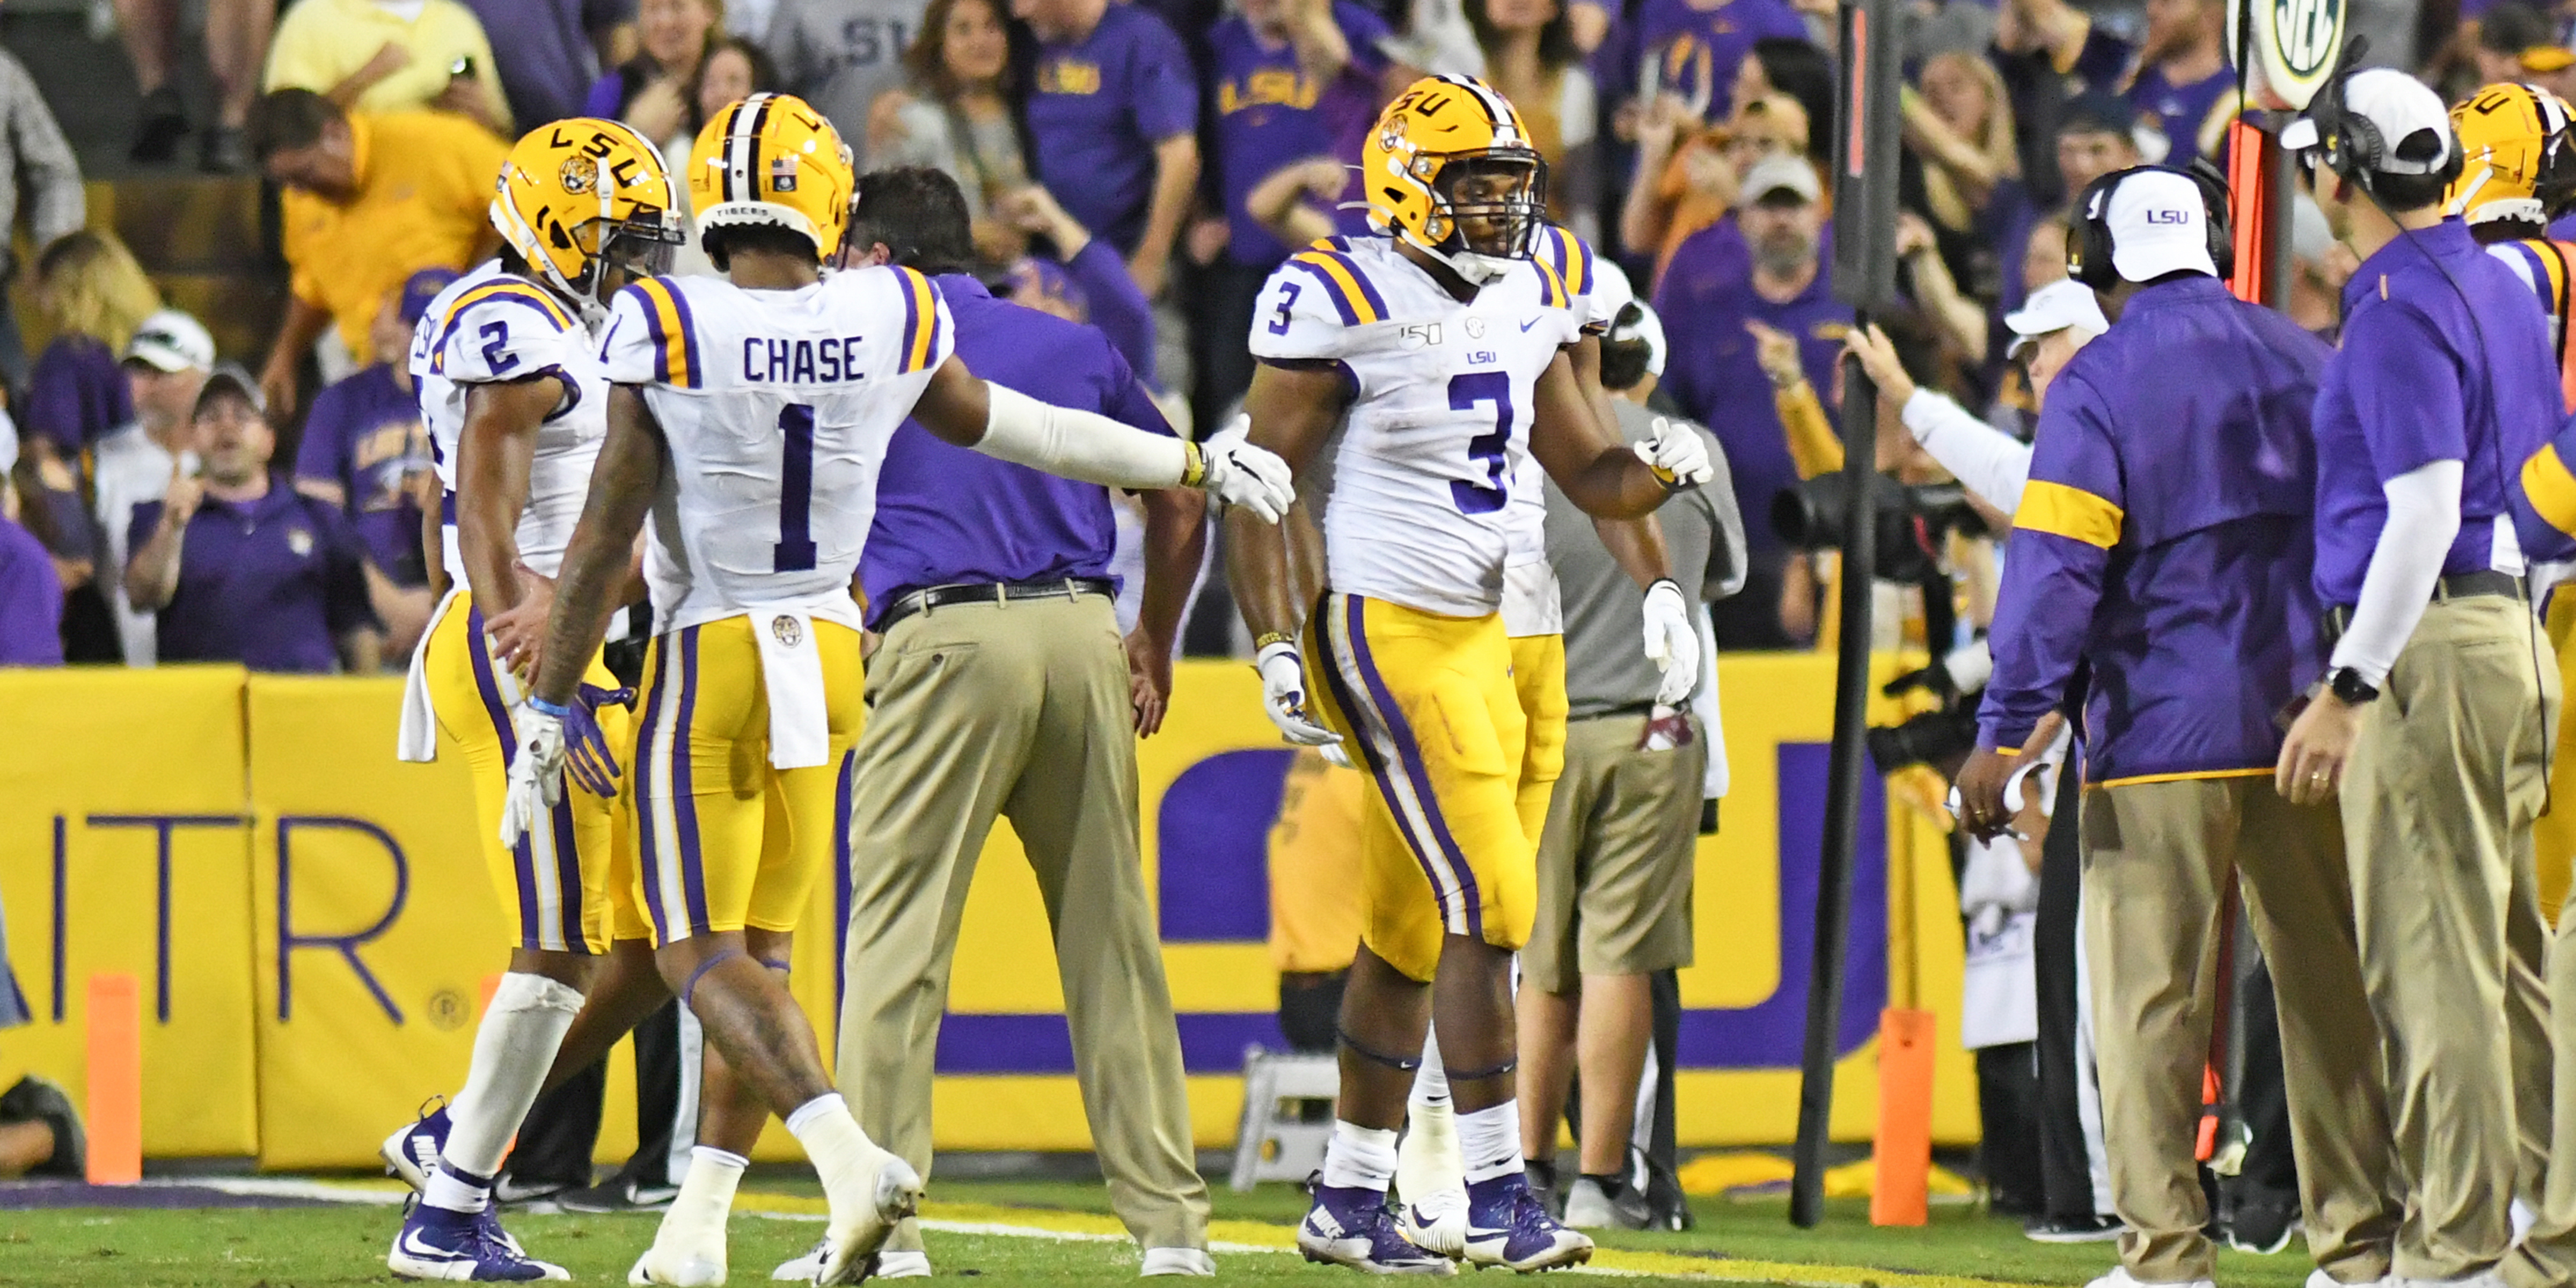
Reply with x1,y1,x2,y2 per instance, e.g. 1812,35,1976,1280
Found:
840,595,1208,1249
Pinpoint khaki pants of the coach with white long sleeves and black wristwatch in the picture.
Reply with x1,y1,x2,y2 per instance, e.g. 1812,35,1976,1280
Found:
2349,595,2558,1280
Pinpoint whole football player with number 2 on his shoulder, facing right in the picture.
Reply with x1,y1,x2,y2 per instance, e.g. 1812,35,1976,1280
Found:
384,119,680,1280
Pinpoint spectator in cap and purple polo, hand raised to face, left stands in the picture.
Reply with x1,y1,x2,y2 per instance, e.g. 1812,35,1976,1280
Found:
126,366,384,672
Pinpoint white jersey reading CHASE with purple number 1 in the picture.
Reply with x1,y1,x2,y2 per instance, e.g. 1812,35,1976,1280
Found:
603,268,956,631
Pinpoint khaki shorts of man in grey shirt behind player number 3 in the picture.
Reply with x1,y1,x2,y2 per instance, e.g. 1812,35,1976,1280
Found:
1520,716,1708,994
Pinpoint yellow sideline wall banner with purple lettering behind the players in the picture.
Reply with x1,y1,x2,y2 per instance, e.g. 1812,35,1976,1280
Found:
0,654,1976,1167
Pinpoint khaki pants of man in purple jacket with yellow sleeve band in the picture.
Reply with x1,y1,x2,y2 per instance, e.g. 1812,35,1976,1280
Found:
2081,773,2398,1283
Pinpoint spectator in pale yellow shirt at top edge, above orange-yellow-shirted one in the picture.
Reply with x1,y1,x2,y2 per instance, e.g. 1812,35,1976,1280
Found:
260,0,510,134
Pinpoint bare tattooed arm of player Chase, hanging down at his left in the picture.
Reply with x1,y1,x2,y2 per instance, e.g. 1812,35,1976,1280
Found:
533,384,670,706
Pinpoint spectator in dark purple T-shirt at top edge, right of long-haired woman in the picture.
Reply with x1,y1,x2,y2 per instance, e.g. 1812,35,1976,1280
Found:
1010,0,1198,299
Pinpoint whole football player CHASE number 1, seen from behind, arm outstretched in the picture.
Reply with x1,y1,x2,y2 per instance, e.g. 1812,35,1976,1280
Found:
502,96,1293,1283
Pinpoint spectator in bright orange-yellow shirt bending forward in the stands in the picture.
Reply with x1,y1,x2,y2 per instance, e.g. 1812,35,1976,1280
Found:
250,91,510,415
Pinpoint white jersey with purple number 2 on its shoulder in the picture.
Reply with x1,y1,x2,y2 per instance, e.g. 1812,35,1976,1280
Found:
409,260,608,585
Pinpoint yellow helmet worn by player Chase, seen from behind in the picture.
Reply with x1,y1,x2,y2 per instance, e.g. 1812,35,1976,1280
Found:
688,93,858,268
